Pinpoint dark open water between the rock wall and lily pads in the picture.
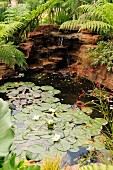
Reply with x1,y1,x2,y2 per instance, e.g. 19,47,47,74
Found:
0,73,93,105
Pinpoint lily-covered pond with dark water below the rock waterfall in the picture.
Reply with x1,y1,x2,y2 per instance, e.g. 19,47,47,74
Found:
0,74,107,165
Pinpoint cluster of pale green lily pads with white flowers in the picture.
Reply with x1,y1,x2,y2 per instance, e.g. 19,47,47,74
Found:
0,82,107,161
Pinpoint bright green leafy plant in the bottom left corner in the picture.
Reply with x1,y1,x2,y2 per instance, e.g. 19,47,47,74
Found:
0,154,40,170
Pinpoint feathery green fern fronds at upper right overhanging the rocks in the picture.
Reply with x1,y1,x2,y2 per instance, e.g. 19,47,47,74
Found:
60,0,113,36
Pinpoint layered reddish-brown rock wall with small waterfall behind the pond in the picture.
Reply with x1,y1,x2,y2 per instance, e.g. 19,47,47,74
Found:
0,25,113,89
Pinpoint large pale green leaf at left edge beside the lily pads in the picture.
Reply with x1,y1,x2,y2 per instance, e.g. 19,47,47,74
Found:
0,98,14,158
